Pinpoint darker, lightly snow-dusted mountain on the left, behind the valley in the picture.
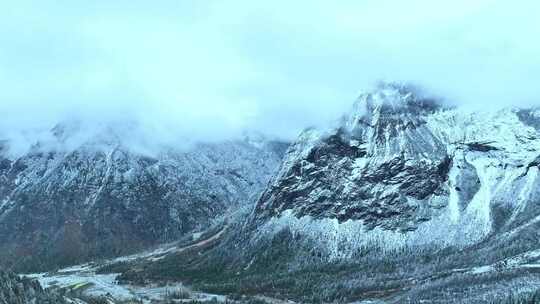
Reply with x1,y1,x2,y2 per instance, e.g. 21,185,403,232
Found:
0,128,286,268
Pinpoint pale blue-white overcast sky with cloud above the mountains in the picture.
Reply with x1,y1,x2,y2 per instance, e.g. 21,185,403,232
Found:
0,0,540,152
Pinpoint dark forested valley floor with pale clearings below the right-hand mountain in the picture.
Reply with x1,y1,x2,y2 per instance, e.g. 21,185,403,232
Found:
16,211,540,304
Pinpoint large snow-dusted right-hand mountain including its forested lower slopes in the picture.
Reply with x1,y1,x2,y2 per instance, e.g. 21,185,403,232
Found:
122,84,540,303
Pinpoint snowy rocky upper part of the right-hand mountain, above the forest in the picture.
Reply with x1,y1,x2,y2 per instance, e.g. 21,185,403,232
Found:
253,84,540,257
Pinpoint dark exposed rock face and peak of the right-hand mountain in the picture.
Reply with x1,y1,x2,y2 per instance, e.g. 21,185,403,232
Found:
256,84,452,231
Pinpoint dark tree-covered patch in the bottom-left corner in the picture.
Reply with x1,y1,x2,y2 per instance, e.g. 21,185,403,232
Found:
0,271,67,304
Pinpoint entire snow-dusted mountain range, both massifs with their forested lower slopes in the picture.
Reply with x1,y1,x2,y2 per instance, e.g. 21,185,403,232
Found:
4,83,540,304
